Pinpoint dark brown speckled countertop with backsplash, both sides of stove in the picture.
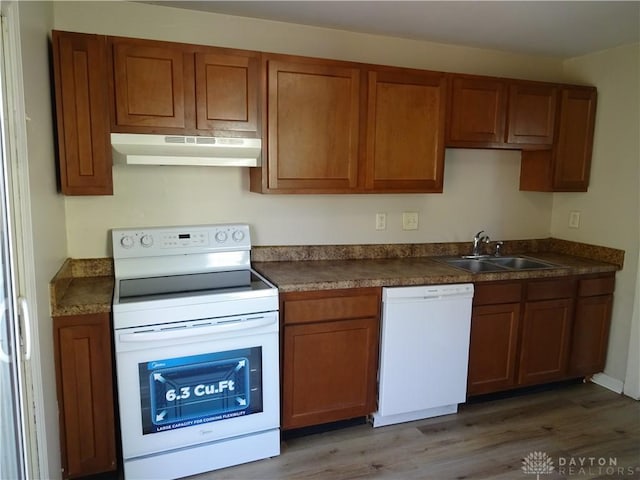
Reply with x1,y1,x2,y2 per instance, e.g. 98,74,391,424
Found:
50,238,624,317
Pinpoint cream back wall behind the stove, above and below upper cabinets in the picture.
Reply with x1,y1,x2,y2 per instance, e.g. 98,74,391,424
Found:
54,2,562,257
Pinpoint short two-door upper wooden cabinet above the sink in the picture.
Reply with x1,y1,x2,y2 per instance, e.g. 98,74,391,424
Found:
447,75,557,148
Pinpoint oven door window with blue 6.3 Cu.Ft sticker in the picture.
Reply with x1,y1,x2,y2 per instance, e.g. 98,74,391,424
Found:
138,347,262,435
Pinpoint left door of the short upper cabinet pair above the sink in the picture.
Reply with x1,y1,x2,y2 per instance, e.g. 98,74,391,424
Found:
447,76,507,147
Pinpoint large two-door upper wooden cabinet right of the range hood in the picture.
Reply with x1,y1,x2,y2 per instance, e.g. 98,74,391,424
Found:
251,55,446,193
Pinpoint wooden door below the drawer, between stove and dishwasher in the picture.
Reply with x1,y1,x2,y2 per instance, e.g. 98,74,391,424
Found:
282,318,379,429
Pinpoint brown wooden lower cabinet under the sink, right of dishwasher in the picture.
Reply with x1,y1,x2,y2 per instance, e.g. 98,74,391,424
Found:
467,273,614,396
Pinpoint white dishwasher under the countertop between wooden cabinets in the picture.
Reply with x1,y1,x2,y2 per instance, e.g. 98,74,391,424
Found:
373,283,473,427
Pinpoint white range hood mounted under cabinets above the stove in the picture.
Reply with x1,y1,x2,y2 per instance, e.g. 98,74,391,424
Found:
111,133,262,167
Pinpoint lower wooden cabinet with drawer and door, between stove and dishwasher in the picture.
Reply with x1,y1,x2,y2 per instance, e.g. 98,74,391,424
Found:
280,288,381,430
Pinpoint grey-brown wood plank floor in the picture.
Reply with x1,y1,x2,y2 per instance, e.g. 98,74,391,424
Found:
191,383,640,480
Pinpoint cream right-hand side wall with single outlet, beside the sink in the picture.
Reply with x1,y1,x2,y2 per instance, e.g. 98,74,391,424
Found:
551,44,640,390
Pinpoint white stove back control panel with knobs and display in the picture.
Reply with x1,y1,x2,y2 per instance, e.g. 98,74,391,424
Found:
111,223,251,259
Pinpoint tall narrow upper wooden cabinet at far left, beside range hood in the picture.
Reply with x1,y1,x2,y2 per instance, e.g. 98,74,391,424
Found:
52,31,113,195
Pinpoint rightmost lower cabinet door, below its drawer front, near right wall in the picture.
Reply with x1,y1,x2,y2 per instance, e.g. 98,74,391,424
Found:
569,295,613,376
